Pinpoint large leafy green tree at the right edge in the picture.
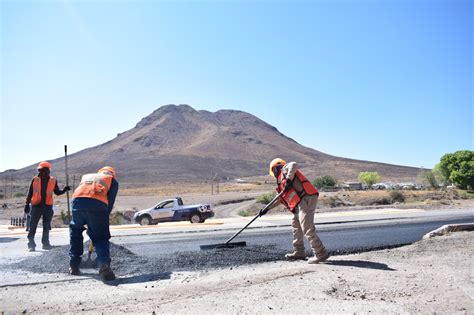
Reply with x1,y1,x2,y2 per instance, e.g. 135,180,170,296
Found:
439,150,474,189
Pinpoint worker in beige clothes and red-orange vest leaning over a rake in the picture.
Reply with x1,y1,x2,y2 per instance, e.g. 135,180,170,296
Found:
260,158,329,264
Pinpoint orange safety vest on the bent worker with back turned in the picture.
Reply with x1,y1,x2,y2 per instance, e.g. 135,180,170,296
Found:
73,173,113,205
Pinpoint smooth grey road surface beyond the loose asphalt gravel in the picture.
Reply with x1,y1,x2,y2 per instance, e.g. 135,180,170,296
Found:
112,214,474,257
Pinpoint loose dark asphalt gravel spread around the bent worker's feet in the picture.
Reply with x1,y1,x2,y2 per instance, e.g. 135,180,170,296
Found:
5,242,285,276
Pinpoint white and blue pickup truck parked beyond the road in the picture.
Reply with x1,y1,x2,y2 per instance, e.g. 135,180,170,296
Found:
133,197,214,225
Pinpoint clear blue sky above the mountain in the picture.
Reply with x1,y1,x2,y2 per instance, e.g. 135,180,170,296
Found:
0,0,474,171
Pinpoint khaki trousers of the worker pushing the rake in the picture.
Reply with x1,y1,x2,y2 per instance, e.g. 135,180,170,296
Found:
291,195,326,257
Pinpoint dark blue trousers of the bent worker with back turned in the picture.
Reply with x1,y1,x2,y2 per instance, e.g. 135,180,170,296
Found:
69,209,110,268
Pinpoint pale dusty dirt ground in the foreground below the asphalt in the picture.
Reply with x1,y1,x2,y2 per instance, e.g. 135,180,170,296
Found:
0,232,474,314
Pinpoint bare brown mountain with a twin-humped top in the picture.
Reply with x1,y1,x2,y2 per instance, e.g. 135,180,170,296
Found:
3,105,419,184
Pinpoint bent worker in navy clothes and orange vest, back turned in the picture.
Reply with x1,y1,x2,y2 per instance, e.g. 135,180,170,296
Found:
69,166,119,281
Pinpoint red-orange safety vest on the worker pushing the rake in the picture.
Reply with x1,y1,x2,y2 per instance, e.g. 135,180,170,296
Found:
276,170,319,212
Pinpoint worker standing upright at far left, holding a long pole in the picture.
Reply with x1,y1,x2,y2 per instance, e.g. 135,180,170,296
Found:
24,162,71,252
